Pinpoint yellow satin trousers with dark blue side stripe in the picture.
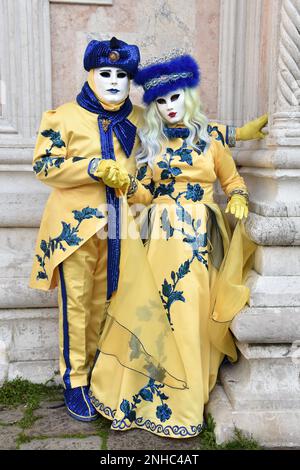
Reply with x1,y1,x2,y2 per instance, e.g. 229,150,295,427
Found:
57,234,107,389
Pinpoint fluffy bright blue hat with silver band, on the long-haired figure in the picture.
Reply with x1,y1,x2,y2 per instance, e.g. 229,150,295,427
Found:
134,49,200,104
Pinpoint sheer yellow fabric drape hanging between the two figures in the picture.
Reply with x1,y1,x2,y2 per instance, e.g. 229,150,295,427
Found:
95,197,187,389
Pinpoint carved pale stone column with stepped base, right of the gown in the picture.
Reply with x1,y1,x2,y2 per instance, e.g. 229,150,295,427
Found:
206,0,300,447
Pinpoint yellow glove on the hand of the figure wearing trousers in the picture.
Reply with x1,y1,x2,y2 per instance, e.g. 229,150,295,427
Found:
95,159,130,193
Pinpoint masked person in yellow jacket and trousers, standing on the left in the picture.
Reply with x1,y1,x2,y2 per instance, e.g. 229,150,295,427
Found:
30,38,263,421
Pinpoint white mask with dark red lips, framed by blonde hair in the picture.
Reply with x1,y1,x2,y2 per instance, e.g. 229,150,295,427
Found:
155,88,185,124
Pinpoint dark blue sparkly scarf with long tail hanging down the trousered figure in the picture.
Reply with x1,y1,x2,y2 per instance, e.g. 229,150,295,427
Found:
77,82,136,300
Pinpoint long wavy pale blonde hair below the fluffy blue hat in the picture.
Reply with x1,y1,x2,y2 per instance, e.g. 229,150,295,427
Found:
136,88,210,168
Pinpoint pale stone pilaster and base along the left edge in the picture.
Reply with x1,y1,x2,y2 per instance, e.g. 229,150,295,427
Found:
0,0,57,383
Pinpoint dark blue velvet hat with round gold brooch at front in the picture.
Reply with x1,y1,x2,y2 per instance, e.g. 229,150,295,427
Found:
83,37,140,78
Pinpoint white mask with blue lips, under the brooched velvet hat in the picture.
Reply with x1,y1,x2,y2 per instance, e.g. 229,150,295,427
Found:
94,67,130,104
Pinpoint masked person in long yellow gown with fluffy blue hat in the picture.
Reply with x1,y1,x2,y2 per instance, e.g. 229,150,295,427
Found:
90,53,255,438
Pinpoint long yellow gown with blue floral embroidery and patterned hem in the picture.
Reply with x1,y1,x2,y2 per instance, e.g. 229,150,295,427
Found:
90,133,255,438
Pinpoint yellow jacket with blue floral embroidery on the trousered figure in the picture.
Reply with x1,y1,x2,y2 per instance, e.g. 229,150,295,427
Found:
29,102,143,290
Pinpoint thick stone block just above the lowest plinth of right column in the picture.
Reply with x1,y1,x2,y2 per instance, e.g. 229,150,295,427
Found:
220,342,300,410
